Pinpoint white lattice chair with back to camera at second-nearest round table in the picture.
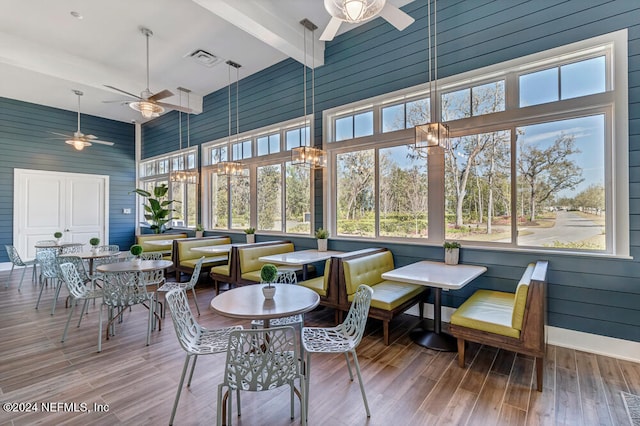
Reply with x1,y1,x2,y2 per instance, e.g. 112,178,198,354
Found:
98,272,155,352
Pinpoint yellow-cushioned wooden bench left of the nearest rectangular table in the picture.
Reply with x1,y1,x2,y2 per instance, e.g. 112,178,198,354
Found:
338,249,429,345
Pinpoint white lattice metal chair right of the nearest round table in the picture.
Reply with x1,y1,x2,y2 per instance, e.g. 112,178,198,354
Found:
302,284,373,417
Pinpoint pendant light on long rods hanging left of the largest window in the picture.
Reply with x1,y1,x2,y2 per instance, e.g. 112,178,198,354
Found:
291,18,328,169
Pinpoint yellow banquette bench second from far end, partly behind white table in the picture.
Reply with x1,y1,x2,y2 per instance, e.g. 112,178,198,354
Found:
172,236,231,281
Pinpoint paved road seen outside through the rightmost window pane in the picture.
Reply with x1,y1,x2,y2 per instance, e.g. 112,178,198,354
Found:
518,211,602,246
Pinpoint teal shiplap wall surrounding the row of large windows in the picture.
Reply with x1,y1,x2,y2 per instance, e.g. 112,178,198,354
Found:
143,0,640,341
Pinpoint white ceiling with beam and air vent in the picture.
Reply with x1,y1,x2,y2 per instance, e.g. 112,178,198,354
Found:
0,0,413,122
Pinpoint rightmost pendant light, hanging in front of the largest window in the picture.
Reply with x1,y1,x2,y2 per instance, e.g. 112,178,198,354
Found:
415,0,450,149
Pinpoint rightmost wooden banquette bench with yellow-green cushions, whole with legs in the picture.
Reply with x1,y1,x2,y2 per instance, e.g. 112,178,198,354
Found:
449,261,548,392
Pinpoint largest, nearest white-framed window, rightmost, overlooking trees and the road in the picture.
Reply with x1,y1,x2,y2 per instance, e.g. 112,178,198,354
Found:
325,32,629,255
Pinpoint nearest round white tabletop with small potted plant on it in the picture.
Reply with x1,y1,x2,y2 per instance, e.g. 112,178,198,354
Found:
211,284,320,320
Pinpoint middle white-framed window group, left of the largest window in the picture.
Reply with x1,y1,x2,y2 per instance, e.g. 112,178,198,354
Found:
202,118,312,235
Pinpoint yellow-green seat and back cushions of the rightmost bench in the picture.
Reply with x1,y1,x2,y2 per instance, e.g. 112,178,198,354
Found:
451,263,535,339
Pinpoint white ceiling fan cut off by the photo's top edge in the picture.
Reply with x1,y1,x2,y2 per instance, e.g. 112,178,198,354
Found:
320,0,415,41
